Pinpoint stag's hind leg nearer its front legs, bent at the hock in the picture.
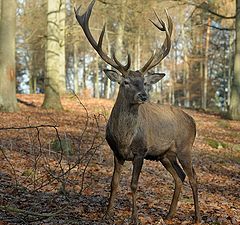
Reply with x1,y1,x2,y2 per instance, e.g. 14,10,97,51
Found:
161,155,185,219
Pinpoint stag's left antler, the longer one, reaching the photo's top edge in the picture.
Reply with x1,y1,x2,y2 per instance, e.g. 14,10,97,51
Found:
74,0,131,76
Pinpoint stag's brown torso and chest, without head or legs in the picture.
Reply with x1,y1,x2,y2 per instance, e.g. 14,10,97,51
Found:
106,100,196,161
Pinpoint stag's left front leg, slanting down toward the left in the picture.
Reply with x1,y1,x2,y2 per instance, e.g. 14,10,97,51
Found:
105,156,124,217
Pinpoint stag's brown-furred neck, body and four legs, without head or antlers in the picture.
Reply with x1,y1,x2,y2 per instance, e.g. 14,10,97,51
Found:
106,80,200,224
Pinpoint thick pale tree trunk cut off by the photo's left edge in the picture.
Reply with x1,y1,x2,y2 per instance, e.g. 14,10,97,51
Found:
0,0,18,112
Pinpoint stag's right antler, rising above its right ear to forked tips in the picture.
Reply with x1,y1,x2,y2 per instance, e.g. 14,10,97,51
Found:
140,10,173,74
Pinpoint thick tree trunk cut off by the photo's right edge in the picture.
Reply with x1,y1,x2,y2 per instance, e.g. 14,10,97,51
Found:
229,0,240,120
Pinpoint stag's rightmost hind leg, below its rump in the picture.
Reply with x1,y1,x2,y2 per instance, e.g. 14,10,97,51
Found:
177,149,201,223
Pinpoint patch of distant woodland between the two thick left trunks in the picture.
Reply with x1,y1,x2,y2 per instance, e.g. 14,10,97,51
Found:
16,0,47,94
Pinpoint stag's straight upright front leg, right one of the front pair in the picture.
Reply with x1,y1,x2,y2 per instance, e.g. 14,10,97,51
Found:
131,156,143,224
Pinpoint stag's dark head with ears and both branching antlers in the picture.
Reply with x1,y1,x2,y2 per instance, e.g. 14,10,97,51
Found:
75,0,173,104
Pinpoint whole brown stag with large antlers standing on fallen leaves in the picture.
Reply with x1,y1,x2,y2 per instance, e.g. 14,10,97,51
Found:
74,0,200,224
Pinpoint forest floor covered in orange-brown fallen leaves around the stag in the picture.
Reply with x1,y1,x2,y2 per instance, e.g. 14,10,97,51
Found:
0,95,240,225
